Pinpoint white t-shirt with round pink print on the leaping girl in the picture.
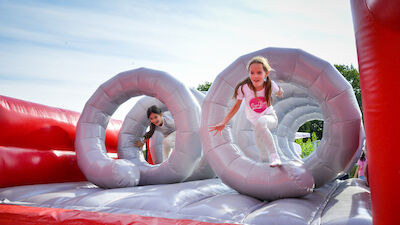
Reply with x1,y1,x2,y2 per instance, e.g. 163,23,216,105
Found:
236,80,279,125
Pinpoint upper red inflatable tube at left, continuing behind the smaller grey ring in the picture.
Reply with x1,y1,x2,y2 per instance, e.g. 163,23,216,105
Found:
0,95,122,152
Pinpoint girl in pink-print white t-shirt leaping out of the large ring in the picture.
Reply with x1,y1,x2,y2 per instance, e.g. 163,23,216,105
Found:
209,56,283,167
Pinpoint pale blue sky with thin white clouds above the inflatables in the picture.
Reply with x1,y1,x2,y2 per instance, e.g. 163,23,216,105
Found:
0,0,358,119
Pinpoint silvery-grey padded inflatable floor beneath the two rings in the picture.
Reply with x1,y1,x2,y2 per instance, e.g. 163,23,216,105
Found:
0,179,372,225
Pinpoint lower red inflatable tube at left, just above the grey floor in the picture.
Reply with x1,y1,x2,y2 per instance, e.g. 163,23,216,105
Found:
0,146,86,188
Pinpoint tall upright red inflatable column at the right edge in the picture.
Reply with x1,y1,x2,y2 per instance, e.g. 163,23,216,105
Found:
351,0,400,225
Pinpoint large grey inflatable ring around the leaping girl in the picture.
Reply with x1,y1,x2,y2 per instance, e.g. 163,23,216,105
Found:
200,48,363,200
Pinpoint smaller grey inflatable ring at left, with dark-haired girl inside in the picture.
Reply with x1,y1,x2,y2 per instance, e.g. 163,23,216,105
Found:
75,68,201,188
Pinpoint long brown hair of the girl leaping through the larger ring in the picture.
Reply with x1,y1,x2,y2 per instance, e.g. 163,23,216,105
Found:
233,56,272,107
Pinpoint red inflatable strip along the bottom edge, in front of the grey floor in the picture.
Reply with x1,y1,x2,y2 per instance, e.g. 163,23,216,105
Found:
0,205,233,225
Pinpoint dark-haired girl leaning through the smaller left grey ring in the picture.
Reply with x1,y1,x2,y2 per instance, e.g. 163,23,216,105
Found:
135,105,176,161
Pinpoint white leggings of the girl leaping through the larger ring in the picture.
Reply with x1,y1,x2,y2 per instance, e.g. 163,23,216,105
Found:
254,112,279,162
